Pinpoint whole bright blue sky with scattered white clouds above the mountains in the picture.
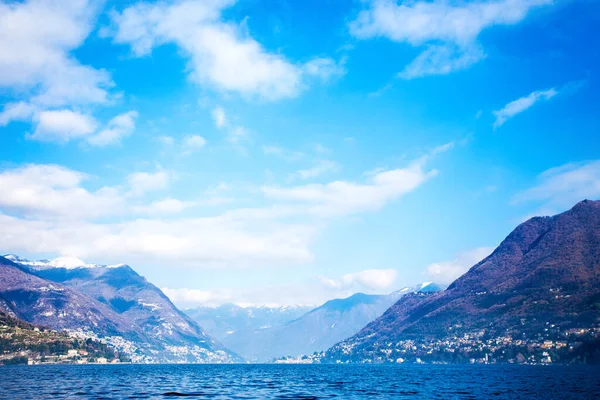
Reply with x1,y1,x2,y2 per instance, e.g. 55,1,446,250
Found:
0,0,600,306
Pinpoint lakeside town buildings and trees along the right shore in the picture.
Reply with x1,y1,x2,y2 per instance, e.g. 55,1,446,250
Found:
274,323,600,365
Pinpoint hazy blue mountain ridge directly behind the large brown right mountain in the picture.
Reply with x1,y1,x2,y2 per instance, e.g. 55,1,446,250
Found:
207,283,435,361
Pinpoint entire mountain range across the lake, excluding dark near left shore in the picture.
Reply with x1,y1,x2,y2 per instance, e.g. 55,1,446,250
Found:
0,200,600,363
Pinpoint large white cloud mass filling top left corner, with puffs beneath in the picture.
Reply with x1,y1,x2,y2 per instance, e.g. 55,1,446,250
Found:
0,0,133,145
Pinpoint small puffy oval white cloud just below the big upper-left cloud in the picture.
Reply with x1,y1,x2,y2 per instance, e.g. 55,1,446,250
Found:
29,110,98,142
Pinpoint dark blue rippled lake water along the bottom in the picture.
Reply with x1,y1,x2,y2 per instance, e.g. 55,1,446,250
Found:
0,365,600,400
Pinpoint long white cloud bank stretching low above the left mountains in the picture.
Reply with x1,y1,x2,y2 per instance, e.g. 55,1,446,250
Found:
0,147,448,272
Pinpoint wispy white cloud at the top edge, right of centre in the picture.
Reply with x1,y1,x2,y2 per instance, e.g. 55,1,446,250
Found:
350,0,552,79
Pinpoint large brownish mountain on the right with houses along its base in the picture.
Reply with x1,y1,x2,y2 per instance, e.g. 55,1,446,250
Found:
323,200,600,362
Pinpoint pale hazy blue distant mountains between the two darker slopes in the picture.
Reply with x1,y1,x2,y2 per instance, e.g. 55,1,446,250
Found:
187,282,440,362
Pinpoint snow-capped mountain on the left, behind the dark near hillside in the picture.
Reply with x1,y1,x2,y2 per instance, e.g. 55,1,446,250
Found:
0,255,238,362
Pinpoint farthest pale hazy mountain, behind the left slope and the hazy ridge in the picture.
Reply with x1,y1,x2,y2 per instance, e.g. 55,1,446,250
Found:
185,304,312,342
